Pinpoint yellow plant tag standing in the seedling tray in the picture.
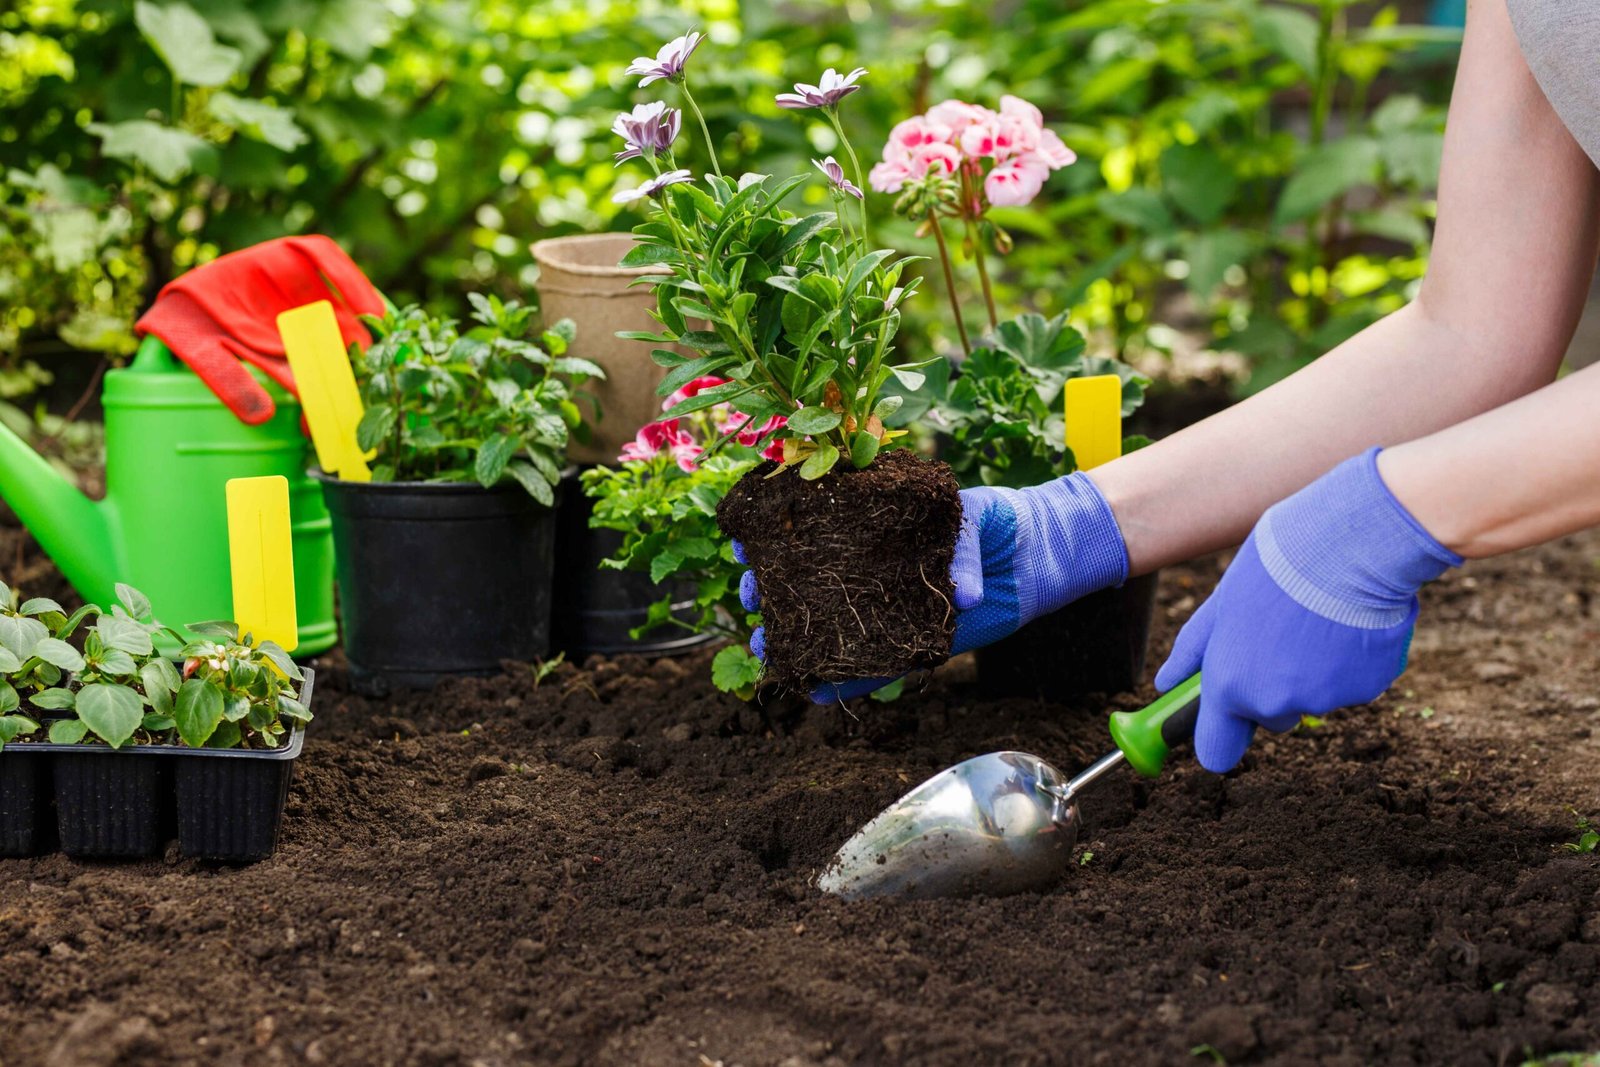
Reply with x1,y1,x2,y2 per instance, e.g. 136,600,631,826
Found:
227,475,299,651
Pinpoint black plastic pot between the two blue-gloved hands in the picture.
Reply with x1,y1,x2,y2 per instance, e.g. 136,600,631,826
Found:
978,573,1158,699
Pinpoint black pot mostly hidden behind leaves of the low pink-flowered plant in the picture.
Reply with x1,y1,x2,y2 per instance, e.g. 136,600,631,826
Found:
550,474,718,659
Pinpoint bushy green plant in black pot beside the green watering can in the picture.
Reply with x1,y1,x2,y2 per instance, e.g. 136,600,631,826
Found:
320,294,603,691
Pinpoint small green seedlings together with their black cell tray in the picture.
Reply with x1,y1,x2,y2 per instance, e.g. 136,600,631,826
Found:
0,585,312,862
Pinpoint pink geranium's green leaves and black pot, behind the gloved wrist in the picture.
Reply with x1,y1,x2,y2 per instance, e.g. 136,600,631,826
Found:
918,314,1157,697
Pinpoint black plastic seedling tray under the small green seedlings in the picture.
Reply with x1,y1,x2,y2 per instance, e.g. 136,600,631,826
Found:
0,669,314,864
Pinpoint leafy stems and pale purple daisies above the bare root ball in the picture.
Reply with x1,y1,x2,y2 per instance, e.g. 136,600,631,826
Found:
614,35,923,480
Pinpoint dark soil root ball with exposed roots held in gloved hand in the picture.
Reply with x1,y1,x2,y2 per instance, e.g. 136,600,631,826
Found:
717,450,962,689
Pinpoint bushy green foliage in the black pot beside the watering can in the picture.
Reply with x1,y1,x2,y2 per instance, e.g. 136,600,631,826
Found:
350,293,605,507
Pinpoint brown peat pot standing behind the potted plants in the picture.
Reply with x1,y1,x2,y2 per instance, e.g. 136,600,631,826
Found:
533,234,691,464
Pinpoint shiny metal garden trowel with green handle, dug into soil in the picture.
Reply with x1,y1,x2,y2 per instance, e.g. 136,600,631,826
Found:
818,675,1200,901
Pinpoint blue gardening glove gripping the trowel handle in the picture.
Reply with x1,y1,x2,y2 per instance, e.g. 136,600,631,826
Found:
1155,448,1461,773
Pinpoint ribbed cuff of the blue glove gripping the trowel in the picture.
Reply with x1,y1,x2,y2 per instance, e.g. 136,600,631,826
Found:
1251,448,1461,630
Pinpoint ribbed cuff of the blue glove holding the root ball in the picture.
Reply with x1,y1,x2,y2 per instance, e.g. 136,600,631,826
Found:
1018,470,1128,622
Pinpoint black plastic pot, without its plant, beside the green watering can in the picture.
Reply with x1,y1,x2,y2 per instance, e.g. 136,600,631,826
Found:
315,474,555,694
